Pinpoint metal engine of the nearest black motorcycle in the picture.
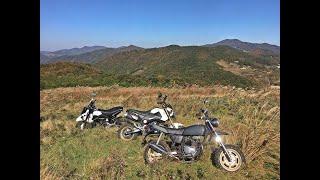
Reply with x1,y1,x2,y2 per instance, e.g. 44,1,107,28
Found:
180,136,203,161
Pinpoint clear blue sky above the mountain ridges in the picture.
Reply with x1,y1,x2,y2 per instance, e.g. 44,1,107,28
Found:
40,0,280,51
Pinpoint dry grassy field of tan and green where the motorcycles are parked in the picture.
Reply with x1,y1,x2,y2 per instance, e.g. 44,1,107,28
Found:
40,86,280,180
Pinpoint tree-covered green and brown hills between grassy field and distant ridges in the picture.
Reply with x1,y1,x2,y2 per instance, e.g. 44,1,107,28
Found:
41,45,280,89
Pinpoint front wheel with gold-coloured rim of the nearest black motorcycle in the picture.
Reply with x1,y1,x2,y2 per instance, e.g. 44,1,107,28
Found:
212,145,245,172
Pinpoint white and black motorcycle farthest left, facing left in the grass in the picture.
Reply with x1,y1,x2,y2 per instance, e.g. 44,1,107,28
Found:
76,94,123,130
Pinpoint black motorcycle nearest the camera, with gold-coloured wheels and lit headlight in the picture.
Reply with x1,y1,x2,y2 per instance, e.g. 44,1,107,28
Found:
144,101,245,172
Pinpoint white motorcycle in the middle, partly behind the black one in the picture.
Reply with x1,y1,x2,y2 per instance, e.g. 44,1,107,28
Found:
118,93,183,141
